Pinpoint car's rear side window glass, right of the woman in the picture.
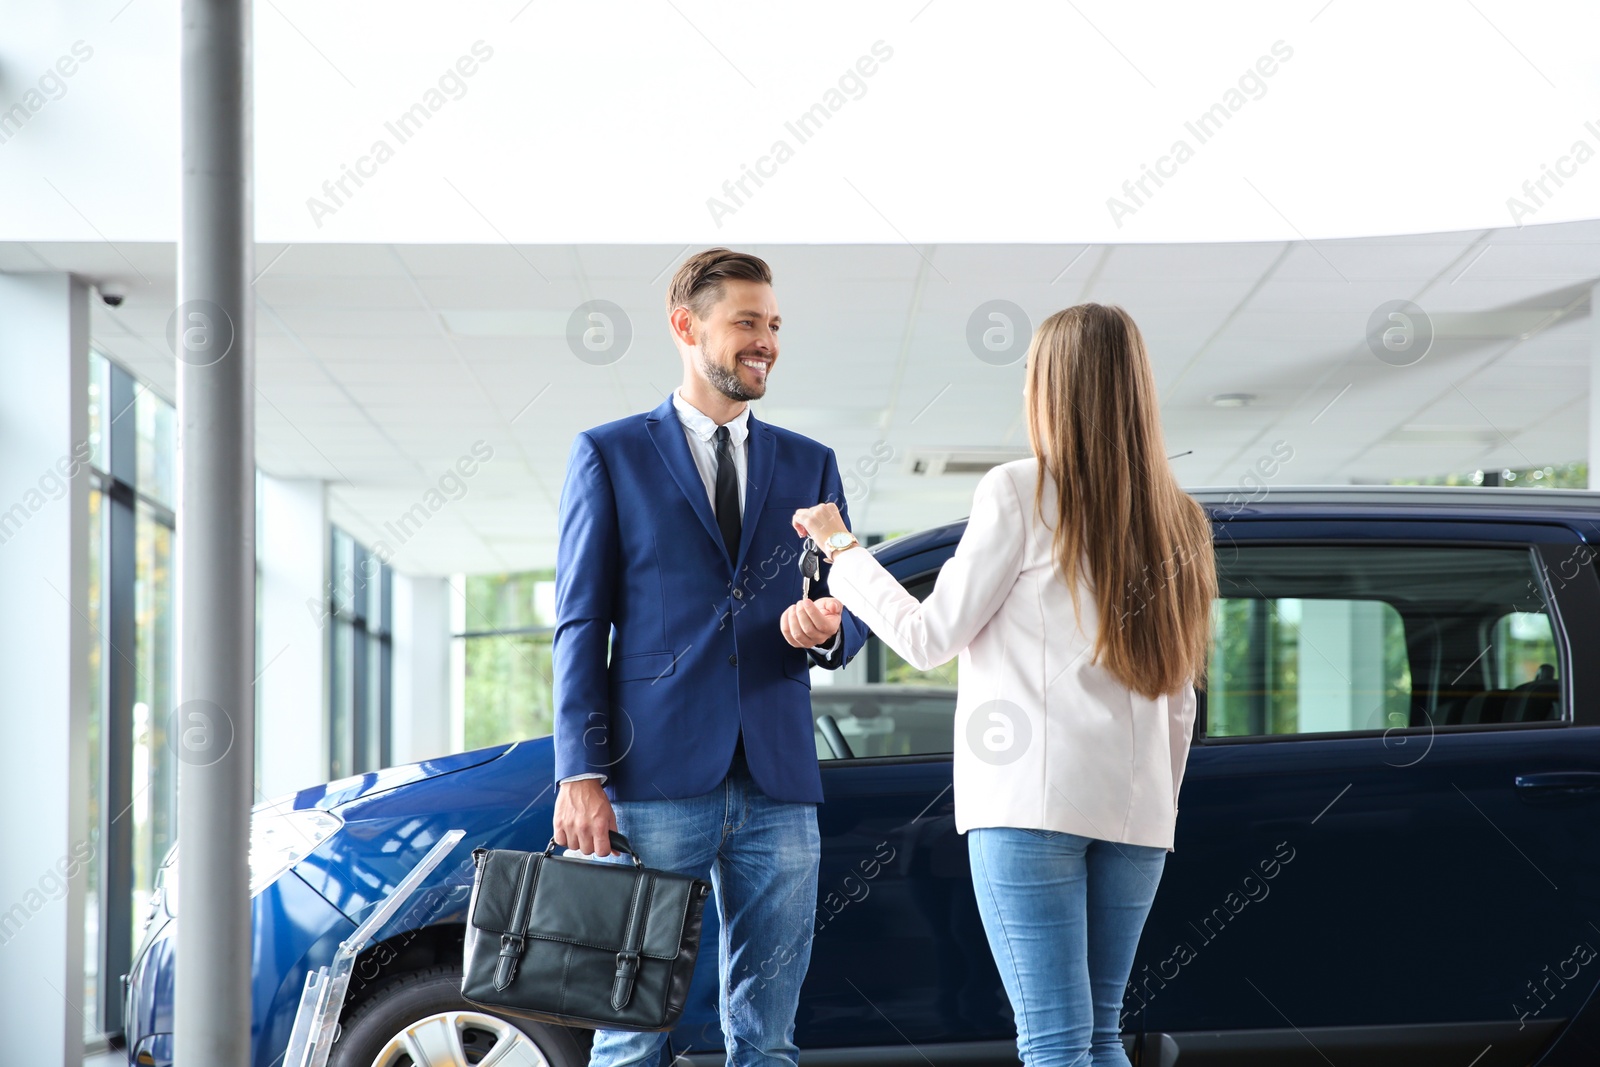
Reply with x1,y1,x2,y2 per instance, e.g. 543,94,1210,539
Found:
1206,544,1562,737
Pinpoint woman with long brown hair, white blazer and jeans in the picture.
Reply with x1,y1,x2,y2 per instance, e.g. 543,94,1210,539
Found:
786,304,1216,1067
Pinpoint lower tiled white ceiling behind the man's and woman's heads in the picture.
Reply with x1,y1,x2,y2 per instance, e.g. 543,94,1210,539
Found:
0,221,1600,574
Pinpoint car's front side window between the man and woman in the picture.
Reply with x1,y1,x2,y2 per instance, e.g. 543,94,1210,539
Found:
811,574,955,760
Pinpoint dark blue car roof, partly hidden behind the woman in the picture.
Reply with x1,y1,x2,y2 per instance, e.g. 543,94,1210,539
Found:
874,485,1600,557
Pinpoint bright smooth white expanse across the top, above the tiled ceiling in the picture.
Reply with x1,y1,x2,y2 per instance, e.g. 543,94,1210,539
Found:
9,0,1600,243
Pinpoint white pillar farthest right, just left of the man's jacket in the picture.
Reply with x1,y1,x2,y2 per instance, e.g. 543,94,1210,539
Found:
389,573,453,763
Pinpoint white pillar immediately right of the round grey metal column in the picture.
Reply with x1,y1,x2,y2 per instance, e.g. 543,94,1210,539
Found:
256,475,331,798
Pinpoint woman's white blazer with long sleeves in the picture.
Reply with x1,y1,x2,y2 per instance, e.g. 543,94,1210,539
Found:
827,459,1195,851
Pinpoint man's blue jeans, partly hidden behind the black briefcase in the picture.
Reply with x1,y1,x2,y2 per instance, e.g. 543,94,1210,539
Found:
589,758,822,1067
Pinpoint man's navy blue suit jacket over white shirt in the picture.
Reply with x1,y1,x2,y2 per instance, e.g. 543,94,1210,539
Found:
552,397,867,803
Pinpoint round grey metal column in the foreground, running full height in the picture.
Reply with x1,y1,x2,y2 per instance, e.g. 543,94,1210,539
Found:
170,0,254,1067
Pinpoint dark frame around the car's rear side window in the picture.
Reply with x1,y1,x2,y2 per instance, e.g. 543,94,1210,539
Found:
1190,528,1580,747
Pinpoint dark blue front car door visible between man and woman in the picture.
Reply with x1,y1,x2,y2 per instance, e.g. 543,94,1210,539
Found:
672,537,1014,1064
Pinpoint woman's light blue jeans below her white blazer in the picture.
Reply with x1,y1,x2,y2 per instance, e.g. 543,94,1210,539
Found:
966,827,1166,1067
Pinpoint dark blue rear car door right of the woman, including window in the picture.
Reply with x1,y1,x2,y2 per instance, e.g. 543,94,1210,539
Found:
1125,518,1600,1067
